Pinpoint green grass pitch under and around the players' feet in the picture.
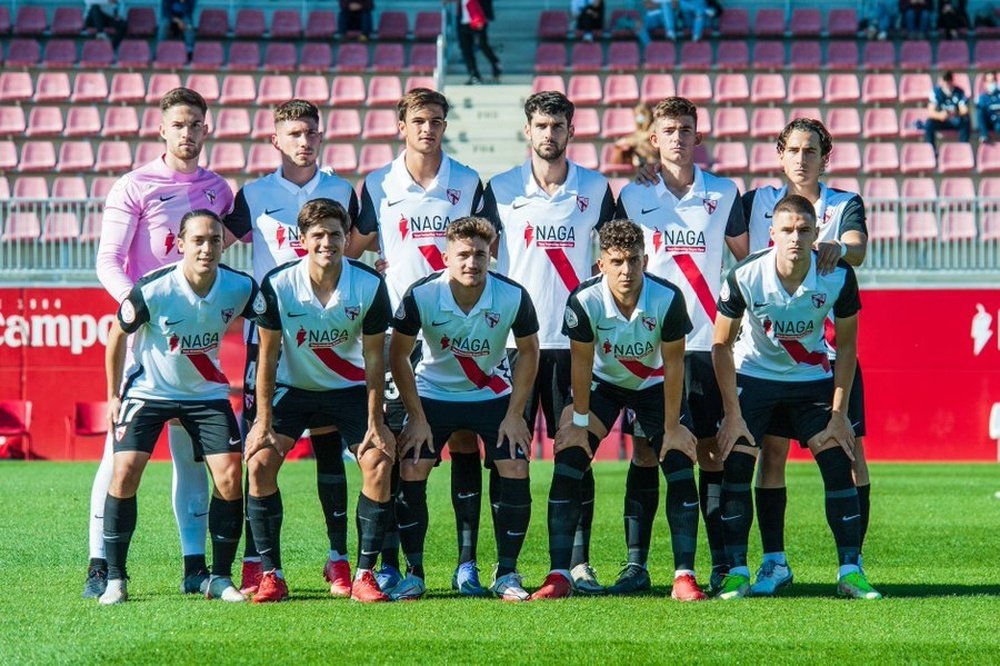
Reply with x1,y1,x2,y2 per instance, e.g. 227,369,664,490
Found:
0,462,1000,665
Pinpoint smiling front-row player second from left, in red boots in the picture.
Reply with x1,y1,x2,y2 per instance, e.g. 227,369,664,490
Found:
244,199,396,603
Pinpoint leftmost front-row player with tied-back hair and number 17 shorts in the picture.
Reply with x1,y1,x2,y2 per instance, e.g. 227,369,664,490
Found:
100,209,254,605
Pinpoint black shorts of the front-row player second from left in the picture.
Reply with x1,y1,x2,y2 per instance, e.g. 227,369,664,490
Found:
272,384,368,446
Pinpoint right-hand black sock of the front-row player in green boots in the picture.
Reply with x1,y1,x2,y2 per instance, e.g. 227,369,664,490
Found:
816,446,861,566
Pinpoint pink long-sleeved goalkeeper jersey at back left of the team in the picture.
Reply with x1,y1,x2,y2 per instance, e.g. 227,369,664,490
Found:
97,155,233,302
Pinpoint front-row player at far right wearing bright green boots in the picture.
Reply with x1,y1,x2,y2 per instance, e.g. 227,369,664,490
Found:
712,194,881,599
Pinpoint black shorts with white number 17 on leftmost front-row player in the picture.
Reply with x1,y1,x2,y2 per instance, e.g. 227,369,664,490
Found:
114,395,243,462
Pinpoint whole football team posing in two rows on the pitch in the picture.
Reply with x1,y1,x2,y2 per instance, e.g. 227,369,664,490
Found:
83,81,881,604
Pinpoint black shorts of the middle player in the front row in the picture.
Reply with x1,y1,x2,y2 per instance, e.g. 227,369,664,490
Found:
412,395,527,466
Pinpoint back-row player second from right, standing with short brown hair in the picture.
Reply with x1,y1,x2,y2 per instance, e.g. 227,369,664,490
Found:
611,97,749,592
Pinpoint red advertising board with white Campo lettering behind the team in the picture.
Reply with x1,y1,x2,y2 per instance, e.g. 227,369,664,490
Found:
0,287,1000,461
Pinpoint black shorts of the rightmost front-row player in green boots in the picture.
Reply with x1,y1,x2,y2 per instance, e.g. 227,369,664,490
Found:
736,373,833,446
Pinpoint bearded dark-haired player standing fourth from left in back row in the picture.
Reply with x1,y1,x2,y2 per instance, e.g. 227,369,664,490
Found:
484,91,615,594
